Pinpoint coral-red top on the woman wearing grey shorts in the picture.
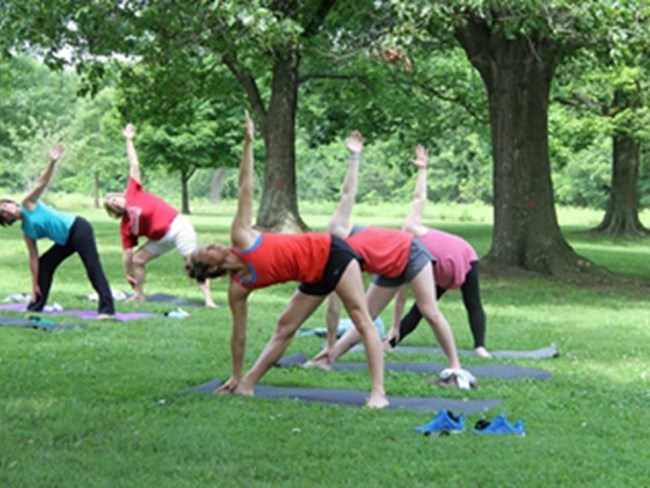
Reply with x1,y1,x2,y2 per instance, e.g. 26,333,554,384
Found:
345,227,413,278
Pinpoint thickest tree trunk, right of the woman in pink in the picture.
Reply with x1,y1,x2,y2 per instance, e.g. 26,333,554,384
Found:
456,19,589,275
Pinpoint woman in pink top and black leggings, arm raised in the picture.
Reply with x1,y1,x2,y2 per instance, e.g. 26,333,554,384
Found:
386,145,490,357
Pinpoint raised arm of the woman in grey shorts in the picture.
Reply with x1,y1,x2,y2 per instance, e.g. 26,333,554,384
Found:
327,131,363,239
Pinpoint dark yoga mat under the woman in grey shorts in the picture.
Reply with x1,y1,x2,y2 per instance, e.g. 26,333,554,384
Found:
276,353,551,380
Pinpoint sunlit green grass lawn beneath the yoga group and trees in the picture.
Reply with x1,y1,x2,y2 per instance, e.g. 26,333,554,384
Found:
0,202,650,487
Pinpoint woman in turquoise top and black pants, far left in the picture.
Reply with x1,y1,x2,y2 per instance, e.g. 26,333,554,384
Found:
0,145,115,318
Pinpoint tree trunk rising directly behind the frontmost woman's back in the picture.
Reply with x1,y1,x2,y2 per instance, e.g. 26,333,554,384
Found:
257,52,307,232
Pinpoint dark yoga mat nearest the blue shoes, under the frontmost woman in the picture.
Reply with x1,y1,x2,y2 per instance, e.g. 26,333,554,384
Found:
183,379,501,414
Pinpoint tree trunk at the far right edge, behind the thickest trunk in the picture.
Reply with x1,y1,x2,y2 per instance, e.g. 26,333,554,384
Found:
594,129,648,236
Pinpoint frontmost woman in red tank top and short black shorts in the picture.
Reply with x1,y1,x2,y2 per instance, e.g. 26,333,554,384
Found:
186,113,388,408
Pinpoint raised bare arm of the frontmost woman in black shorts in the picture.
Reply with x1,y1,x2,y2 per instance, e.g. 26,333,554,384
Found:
230,111,258,249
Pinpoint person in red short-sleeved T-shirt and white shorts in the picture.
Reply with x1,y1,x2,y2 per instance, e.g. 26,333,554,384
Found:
104,124,217,307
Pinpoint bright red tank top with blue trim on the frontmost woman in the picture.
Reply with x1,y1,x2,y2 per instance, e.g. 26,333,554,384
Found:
232,232,332,289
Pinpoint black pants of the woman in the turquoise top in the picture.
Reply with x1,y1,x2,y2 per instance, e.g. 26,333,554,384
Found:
27,217,115,314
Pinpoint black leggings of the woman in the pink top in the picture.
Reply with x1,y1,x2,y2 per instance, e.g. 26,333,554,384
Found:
390,261,485,348
